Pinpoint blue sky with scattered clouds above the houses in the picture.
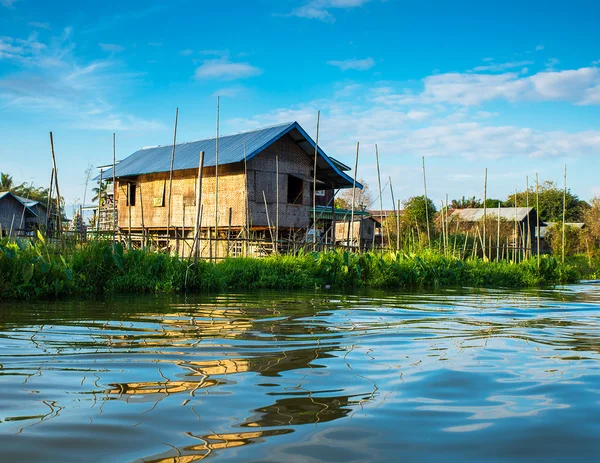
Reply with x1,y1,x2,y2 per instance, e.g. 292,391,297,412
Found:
0,0,600,207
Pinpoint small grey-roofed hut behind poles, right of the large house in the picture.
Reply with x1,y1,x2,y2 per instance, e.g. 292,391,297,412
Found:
450,207,543,253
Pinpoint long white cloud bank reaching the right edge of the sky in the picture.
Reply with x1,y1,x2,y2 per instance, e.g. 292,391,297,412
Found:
373,67,600,106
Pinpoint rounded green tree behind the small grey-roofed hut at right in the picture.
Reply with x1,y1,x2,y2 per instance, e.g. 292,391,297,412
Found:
504,181,589,222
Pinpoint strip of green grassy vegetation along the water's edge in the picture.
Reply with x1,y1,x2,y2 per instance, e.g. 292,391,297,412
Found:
0,240,600,300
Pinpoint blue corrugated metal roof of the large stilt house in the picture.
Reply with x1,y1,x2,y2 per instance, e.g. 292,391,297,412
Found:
96,122,362,188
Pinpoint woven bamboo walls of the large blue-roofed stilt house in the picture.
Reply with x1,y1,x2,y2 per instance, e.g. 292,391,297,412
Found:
116,135,313,231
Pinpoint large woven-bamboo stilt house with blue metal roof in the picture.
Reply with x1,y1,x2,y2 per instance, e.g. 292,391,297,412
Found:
97,122,362,256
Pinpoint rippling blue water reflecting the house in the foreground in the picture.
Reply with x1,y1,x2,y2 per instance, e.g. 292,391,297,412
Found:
0,284,600,463
